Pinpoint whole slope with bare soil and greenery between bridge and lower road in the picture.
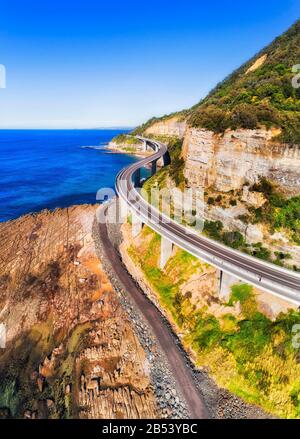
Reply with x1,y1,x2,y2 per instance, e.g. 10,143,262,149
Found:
121,225,300,418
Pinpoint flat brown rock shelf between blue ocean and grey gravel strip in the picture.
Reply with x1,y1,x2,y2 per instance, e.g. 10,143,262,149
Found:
0,206,158,419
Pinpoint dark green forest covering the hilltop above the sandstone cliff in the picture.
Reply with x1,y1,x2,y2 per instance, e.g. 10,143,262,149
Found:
188,21,300,143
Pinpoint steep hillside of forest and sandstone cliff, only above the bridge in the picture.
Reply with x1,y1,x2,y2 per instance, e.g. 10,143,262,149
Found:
128,21,300,270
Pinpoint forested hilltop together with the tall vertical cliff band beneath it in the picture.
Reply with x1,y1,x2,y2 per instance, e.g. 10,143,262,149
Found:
135,21,300,196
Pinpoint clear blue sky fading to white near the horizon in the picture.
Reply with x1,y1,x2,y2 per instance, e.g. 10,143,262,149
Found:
0,0,300,128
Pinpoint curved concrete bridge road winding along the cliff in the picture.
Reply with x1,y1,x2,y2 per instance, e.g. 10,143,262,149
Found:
116,137,300,305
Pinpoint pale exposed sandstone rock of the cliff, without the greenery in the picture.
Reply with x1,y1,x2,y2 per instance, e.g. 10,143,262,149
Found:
134,112,300,267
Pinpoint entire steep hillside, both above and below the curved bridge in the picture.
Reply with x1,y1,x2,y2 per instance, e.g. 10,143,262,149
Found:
105,21,300,418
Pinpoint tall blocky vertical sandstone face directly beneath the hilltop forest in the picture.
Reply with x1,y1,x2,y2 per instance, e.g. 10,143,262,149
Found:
183,128,300,196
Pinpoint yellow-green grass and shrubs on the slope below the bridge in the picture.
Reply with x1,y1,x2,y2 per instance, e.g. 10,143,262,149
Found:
129,227,300,418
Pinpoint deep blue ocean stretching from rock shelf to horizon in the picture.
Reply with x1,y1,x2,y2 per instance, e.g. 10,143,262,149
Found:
0,130,137,221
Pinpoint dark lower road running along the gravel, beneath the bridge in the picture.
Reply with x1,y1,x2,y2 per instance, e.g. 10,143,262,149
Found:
99,211,209,419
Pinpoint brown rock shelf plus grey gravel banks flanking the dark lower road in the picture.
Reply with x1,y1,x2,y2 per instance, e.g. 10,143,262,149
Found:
0,201,270,419
